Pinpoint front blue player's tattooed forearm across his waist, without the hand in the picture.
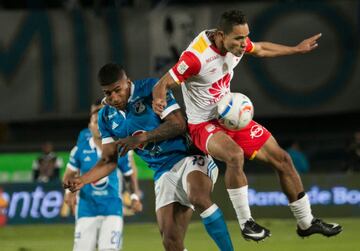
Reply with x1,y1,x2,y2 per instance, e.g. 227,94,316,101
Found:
145,117,186,143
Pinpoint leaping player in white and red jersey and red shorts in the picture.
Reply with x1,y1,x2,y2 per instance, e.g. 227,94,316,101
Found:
153,10,342,241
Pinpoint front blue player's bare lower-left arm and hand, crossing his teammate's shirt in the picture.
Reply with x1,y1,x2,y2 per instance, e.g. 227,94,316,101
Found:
65,143,118,192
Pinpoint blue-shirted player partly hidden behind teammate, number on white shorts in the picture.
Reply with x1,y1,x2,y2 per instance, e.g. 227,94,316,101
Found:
64,101,142,251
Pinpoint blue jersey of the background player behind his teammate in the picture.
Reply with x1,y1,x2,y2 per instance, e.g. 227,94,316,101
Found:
67,135,132,218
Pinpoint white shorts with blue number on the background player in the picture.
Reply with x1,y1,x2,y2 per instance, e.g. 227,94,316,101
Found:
73,215,124,251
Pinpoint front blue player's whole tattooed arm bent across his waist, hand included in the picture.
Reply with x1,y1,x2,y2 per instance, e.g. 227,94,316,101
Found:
116,110,186,156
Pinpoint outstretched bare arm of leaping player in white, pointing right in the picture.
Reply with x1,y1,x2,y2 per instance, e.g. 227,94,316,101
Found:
250,33,321,57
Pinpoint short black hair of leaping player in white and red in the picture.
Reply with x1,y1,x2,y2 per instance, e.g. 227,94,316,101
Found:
217,10,247,34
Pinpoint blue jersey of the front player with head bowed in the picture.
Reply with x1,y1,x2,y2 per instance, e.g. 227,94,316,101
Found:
98,78,188,180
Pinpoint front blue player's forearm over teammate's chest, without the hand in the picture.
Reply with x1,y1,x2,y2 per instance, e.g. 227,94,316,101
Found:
81,158,117,184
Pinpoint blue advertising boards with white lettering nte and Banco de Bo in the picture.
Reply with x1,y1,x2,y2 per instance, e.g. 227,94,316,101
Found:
0,174,360,225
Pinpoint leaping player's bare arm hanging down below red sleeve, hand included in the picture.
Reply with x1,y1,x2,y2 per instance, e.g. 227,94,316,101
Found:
153,72,178,115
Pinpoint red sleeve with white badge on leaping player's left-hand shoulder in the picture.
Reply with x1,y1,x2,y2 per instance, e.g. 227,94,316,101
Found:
169,51,201,84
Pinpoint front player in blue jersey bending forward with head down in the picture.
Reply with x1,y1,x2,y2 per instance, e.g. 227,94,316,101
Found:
66,64,233,251
